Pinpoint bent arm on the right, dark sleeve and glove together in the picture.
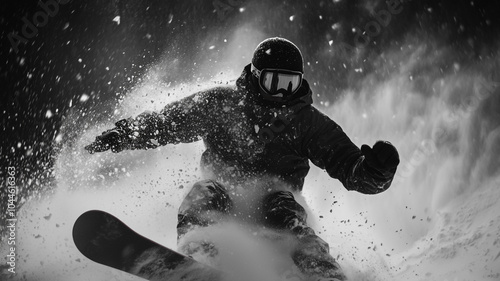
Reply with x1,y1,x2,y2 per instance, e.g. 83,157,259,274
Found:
303,109,399,194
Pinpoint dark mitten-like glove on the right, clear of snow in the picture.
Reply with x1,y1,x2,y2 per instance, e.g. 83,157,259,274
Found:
361,141,399,173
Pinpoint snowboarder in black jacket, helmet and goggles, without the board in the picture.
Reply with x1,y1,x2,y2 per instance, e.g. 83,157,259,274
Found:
86,38,399,280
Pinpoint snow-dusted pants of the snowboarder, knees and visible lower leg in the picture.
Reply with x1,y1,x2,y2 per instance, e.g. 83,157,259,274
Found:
177,180,345,281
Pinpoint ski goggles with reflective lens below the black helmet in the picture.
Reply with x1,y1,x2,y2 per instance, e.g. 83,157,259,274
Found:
250,64,302,98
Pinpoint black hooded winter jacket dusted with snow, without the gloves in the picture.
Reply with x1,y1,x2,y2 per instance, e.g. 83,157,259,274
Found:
117,65,395,194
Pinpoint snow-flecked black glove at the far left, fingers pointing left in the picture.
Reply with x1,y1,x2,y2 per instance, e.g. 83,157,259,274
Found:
85,119,134,154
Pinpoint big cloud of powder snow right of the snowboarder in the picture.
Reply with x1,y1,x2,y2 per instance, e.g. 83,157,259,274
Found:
305,40,500,280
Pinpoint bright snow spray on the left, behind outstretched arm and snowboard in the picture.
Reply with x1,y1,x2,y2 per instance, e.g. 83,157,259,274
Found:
0,26,270,281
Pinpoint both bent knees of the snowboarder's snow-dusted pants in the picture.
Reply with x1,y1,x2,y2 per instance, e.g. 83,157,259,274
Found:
177,180,314,238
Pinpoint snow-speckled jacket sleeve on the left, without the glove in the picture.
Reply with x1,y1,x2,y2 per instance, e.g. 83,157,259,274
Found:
116,88,222,149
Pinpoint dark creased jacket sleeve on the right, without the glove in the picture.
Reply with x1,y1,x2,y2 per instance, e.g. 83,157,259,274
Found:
302,108,395,194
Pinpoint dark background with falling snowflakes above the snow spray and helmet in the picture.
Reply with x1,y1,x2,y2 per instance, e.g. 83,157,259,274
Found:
0,0,500,217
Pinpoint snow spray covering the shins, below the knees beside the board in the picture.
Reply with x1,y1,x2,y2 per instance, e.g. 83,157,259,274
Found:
179,222,301,281
